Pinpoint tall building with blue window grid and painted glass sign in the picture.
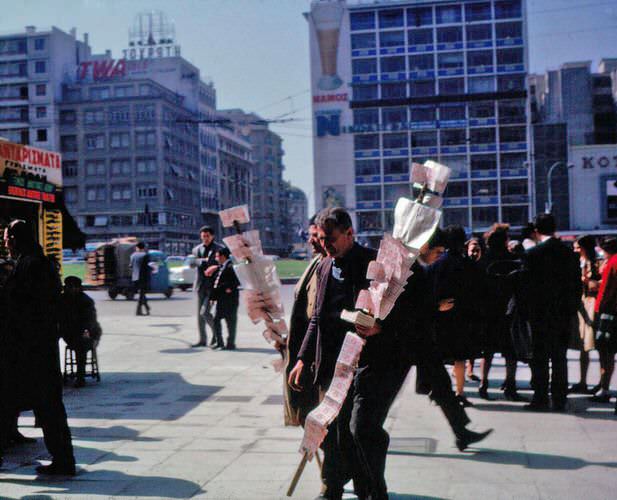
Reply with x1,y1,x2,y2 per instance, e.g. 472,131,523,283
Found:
308,0,533,241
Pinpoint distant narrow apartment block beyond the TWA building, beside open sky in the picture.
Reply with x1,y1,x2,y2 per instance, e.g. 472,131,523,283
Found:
218,109,289,254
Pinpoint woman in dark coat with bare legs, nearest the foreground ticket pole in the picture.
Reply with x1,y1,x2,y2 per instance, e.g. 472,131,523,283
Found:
429,226,481,406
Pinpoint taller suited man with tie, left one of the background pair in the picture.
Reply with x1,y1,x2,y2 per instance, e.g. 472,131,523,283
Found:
192,226,223,347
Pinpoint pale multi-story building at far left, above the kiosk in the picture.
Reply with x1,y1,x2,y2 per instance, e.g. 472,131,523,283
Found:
0,26,90,151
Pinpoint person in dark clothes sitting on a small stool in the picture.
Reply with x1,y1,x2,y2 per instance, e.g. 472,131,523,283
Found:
58,276,102,387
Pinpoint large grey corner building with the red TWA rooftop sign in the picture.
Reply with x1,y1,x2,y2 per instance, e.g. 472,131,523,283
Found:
59,13,221,254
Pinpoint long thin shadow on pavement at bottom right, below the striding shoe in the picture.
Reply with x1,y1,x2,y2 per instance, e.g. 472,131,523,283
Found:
388,448,617,470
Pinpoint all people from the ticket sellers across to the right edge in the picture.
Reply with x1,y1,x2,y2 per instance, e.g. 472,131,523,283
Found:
285,208,617,500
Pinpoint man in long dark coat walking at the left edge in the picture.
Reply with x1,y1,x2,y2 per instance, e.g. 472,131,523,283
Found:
0,220,75,475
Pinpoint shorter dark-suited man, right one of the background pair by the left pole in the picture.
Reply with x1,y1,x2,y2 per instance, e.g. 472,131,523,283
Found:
211,247,240,351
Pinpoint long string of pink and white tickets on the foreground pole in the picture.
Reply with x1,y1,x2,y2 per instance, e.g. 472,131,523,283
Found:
300,160,450,460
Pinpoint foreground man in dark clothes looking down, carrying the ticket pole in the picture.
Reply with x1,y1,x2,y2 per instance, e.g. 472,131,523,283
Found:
288,208,411,499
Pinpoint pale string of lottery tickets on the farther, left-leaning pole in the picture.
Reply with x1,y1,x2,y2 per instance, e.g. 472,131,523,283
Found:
219,205,288,345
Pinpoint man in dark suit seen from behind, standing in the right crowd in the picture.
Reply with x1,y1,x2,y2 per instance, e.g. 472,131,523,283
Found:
524,214,582,411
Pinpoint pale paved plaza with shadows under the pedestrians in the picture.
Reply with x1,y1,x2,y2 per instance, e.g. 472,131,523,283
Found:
0,285,617,499
